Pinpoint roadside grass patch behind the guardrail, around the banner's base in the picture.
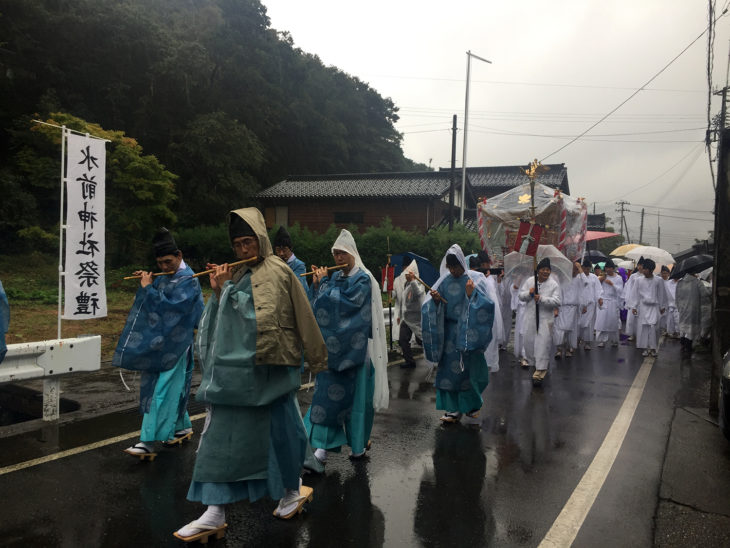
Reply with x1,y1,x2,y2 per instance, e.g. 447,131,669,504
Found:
0,253,210,361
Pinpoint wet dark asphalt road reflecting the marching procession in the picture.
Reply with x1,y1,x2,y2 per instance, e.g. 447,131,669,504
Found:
0,341,706,547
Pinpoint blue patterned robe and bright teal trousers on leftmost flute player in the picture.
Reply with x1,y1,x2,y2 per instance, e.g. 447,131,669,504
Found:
112,265,203,432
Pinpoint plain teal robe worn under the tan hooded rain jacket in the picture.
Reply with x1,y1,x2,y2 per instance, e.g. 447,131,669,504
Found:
188,270,307,504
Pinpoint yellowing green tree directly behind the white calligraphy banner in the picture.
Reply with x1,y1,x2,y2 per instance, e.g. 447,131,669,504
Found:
0,112,175,264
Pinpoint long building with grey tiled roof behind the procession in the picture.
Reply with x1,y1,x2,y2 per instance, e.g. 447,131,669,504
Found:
256,164,569,232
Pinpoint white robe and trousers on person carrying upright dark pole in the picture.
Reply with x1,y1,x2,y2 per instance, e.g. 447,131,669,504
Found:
520,277,560,370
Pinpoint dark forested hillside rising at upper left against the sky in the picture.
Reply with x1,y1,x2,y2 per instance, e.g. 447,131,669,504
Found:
0,0,420,235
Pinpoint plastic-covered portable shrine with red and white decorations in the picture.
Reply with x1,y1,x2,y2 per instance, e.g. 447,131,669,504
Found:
477,182,588,262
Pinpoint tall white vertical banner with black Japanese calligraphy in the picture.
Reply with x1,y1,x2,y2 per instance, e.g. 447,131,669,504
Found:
62,132,106,320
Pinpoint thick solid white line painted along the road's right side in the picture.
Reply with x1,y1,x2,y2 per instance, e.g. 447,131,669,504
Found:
538,358,655,548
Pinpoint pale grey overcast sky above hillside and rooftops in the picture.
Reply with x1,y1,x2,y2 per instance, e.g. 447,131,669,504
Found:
262,0,730,252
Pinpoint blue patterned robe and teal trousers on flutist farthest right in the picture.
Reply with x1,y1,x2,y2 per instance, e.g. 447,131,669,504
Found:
421,274,494,413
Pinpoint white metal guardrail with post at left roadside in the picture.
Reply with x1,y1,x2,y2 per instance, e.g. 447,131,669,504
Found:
0,335,101,420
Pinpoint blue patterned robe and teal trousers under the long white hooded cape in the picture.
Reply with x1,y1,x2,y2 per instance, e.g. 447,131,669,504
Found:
304,270,375,453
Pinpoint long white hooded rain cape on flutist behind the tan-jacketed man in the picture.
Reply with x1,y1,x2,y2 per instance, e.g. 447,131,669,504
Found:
332,229,390,410
